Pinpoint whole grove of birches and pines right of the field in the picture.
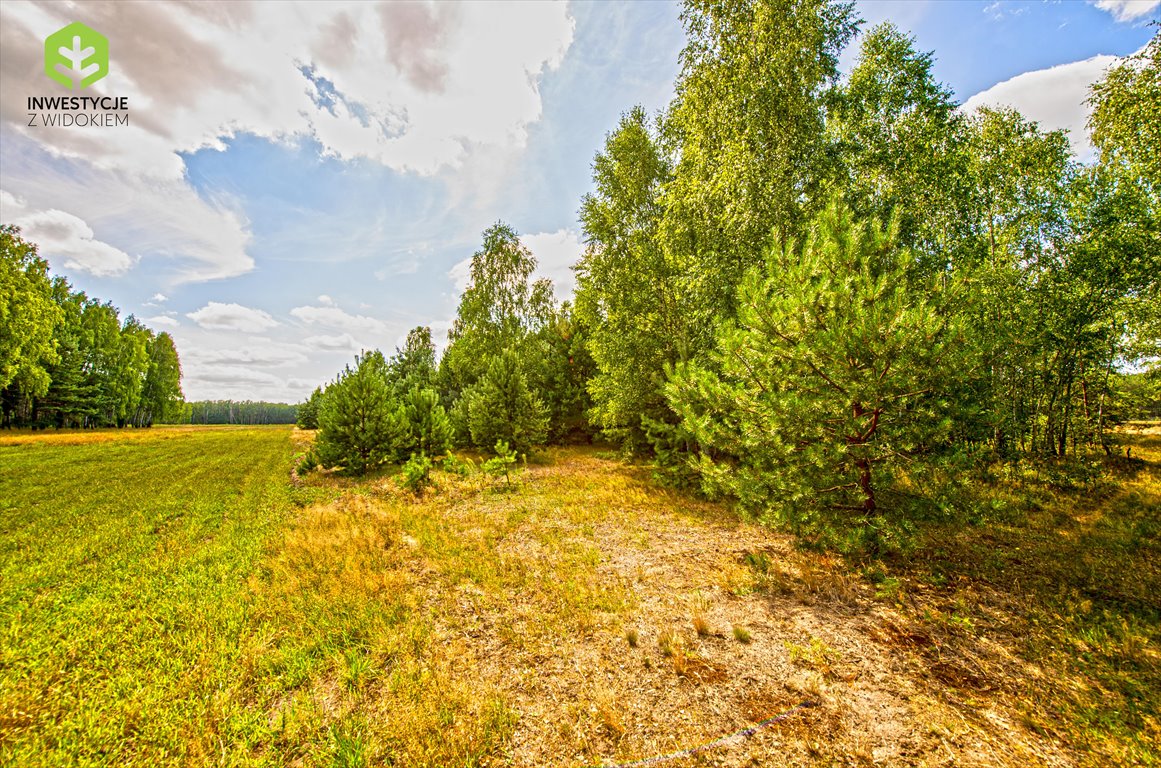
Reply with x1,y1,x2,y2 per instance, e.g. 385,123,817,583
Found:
300,0,1161,545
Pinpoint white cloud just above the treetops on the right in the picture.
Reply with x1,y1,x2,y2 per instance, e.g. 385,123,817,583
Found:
962,56,1119,162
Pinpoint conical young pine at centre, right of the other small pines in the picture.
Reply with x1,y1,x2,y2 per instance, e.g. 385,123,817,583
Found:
464,350,548,452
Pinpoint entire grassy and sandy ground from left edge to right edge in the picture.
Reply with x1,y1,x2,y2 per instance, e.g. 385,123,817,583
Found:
0,426,1161,766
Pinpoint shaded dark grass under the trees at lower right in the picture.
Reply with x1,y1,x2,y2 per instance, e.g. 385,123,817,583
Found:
875,425,1161,766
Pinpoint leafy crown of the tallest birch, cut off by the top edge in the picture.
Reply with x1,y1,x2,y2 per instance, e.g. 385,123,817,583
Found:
665,0,856,257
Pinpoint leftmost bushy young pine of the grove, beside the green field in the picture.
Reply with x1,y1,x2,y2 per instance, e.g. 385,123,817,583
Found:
315,350,401,474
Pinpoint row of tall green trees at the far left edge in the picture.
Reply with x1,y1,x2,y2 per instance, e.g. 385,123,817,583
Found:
0,225,182,429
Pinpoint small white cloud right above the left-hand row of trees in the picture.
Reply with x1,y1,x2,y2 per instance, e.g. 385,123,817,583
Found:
0,189,134,278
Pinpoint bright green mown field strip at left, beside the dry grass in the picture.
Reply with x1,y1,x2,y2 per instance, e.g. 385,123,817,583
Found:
0,429,293,766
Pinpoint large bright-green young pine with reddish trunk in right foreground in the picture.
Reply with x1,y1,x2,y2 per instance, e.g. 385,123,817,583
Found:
666,197,956,548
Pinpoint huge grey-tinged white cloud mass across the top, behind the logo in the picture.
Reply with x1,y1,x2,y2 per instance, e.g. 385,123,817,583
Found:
2,1,575,178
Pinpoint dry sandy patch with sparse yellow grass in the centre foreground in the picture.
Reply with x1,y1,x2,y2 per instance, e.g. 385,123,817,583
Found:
362,451,1133,766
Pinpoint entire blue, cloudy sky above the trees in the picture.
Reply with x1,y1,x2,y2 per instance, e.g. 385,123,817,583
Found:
0,0,1161,402
